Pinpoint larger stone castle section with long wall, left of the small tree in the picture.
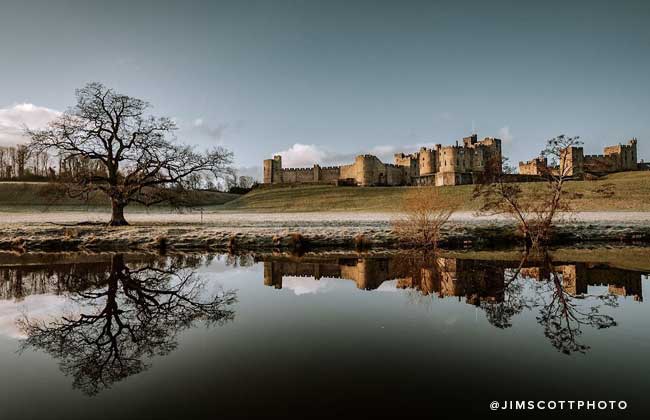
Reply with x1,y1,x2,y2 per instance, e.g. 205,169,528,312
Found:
264,134,501,187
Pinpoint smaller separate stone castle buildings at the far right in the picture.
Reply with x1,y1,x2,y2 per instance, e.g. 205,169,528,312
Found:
519,138,639,176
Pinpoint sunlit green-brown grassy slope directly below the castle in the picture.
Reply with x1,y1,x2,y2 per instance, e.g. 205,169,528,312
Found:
223,171,650,212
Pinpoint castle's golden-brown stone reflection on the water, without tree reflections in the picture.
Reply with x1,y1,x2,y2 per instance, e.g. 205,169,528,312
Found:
258,256,644,306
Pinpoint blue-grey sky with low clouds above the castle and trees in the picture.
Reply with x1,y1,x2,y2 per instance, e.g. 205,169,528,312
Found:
0,0,650,176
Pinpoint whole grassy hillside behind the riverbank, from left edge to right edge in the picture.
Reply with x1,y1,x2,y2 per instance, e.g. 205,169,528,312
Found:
0,171,650,212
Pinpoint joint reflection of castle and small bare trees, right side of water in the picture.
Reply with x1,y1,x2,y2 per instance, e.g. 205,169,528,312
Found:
254,253,644,354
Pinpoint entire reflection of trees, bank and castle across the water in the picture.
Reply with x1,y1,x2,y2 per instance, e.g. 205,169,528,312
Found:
0,249,646,395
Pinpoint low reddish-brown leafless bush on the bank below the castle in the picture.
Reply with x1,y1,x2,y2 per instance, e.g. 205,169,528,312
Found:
392,187,460,248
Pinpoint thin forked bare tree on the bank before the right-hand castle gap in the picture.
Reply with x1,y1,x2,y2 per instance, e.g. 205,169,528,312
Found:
474,135,581,248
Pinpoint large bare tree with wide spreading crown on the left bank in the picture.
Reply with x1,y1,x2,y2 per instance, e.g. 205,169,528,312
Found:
26,83,232,226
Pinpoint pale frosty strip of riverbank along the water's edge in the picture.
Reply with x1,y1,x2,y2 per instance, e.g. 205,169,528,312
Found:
0,212,650,252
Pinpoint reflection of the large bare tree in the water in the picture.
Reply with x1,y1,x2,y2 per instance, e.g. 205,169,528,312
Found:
19,254,236,395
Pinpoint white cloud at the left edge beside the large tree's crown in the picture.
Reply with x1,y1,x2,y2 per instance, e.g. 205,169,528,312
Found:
0,104,61,146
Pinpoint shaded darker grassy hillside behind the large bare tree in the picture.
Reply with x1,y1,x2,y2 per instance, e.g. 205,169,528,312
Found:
0,182,239,211
